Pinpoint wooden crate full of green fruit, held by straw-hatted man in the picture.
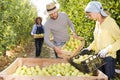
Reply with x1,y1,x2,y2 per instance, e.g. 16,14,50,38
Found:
59,36,85,57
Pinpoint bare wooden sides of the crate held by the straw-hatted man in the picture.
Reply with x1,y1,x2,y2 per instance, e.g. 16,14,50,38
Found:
58,36,85,59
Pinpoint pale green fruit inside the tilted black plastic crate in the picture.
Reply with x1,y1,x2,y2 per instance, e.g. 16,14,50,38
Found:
73,54,93,64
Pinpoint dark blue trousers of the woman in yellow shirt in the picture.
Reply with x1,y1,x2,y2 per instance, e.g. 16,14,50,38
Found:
99,56,115,80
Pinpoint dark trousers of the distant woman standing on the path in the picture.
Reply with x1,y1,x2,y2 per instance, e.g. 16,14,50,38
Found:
35,38,44,57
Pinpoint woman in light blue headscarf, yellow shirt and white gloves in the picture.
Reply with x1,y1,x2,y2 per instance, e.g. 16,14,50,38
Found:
82,1,120,80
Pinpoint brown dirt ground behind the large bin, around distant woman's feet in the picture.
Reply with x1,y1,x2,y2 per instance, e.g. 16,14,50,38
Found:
0,42,55,71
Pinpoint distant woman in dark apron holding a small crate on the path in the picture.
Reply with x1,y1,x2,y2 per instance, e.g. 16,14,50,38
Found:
31,17,44,57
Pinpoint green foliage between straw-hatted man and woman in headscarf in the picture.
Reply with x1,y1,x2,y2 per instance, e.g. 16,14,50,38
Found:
58,0,94,44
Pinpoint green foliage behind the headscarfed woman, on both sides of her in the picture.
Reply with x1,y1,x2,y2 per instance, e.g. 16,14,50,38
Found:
58,0,120,47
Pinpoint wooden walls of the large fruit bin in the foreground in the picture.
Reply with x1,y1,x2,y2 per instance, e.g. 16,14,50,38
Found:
0,58,108,80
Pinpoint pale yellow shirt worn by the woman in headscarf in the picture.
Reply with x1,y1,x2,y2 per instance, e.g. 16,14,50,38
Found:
89,16,120,58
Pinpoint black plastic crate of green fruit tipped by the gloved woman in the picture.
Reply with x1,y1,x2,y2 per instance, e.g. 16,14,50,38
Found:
70,52,105,73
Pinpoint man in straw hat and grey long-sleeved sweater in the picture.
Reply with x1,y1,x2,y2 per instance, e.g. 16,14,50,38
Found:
44,3,76,58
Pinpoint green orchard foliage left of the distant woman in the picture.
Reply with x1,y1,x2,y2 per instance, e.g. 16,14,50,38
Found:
0,0,36,54
